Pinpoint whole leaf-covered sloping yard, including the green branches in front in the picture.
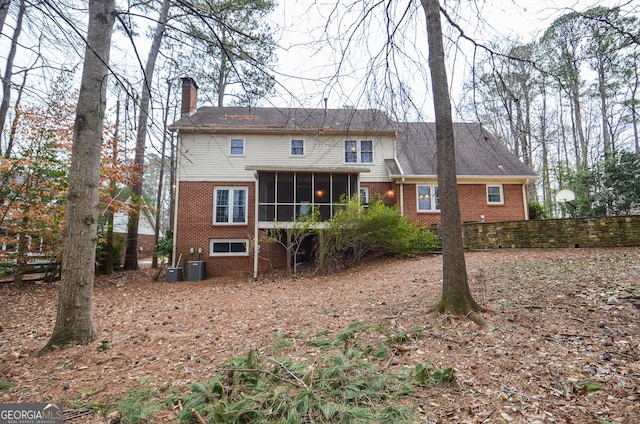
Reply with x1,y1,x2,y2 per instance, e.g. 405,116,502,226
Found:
0,248,640,423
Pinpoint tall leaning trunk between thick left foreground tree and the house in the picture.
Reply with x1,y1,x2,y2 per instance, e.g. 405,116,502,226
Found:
124,0,171,270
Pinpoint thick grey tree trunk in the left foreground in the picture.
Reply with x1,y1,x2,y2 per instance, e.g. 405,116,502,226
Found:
45,0,116,350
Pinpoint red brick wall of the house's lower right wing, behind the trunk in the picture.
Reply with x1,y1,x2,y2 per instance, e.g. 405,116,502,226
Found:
404,184,526,226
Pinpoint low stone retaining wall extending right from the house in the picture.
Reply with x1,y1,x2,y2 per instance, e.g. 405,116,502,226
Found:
463,216,640,249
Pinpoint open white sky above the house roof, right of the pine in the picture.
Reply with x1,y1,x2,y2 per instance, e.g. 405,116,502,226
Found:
264,0,640,119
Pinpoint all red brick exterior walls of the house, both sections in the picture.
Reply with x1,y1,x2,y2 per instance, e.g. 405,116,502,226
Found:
175,181,525,278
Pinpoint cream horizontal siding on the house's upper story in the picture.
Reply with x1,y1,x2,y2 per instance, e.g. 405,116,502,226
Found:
178,134,394,182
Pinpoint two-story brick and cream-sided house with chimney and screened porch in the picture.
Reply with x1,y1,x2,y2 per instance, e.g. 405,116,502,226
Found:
170,78,537,277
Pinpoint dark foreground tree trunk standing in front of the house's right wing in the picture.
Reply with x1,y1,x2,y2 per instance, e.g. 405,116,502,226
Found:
422,0,479,315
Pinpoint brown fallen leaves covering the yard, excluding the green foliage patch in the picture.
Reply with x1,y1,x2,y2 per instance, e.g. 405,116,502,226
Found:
0,248,640,423
